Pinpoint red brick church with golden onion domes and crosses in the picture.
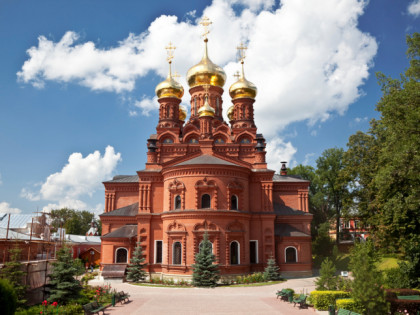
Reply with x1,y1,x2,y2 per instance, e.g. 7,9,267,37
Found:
100,19,312,279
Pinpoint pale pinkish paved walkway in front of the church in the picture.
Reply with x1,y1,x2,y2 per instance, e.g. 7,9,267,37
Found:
90,277,326,315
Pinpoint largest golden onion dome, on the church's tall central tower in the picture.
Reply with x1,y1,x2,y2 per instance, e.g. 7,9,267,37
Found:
187,39,226,87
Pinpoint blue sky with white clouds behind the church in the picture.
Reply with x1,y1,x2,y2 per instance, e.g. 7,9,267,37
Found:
0,0,420,214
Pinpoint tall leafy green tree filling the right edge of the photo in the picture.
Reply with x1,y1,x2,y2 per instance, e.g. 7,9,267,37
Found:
344,33,420,251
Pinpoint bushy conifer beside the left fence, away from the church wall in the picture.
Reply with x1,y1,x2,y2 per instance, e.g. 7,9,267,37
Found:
48,246,82,304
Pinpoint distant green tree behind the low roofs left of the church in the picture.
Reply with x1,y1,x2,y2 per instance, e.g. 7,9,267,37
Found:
50,208,94,235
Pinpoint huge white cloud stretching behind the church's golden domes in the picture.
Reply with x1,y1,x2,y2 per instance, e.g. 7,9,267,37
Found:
18,0,377,156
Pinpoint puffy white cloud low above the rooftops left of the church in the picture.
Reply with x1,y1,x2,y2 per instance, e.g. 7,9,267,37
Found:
21,146,121,210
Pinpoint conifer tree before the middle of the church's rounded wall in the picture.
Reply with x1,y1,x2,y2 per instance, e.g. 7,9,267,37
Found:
192,232,220,287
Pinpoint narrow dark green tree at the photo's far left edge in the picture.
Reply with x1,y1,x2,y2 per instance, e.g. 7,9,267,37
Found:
0,244,26,306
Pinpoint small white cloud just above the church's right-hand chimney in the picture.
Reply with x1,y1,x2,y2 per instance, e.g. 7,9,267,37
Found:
266,137,297,171
